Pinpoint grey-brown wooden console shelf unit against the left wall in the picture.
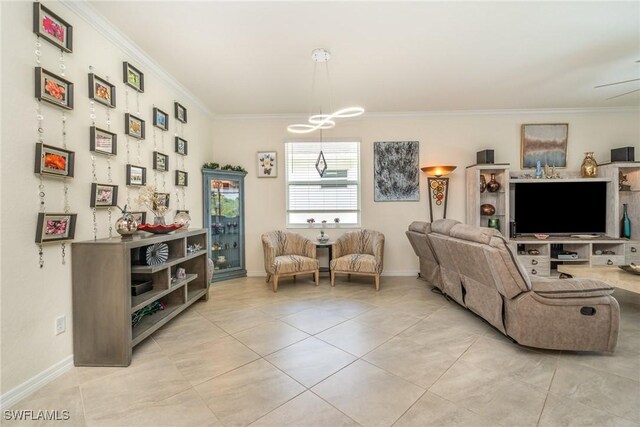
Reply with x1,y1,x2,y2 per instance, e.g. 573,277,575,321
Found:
71,229,209,366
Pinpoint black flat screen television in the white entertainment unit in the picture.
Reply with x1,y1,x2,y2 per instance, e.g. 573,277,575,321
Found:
513,181,607,235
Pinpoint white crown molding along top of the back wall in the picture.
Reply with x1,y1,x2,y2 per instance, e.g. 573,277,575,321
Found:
213,107,640,120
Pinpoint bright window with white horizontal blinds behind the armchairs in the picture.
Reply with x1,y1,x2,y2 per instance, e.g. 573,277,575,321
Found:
285,141,360,226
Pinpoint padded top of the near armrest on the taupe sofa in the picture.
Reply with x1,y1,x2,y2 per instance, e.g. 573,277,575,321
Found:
531,278,614,299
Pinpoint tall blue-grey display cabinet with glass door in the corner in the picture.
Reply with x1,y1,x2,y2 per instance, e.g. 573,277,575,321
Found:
202,169,247,282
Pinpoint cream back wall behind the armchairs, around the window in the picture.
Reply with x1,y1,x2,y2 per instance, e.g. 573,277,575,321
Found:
213,110,640,275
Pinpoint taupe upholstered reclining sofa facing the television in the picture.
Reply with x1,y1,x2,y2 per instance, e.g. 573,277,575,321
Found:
406,219,620,352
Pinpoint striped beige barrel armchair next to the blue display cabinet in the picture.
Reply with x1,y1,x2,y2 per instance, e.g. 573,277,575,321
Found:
262,231,320,292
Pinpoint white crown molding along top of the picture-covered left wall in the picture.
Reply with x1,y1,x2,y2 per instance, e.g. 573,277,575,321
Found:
61,0,215,118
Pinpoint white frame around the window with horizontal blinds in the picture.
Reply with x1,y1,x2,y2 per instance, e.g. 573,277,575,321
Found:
284,138,362,228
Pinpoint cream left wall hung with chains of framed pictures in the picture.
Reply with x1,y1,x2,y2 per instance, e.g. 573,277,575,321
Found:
0,1,211,394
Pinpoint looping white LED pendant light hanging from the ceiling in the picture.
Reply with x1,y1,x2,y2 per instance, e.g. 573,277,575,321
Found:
287,48,364,134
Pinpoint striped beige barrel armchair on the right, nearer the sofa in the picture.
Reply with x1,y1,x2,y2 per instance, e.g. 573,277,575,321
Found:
331,230,384,291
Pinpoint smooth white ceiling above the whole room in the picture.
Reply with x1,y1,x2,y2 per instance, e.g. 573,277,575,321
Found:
90,1,640,115
